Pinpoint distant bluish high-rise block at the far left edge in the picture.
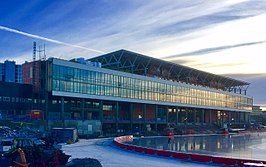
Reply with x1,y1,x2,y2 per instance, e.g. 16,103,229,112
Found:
0,60,22,83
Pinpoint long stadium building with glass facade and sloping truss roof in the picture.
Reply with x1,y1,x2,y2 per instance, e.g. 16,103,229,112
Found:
23,50,253,133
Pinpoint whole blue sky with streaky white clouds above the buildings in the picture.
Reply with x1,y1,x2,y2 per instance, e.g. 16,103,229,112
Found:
0,0,266,107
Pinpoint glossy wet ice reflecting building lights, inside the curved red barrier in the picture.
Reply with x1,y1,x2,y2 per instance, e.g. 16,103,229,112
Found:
131,135,266,159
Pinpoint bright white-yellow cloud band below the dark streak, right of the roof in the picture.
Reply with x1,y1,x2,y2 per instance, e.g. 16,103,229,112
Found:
168,43,266,74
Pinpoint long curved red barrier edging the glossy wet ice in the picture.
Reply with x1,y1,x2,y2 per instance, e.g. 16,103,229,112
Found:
113,135,266,166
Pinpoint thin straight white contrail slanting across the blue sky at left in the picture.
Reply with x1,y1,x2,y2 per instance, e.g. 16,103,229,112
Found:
0,25,105,53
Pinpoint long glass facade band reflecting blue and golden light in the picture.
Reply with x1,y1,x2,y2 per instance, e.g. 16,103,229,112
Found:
51,64,253,111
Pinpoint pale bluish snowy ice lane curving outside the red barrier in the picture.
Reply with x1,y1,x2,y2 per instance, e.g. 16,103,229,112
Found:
62,139,220,167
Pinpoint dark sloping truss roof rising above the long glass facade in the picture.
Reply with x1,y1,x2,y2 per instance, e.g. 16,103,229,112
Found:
89,50,249,94
